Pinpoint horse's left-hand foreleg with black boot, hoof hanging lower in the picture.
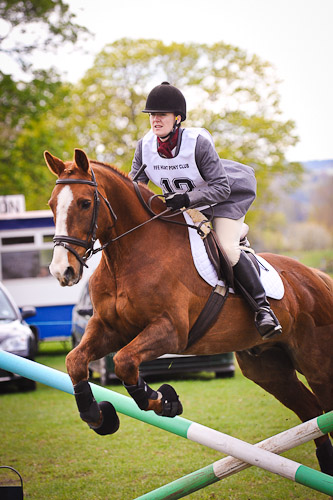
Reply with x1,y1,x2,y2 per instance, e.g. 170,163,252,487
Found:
66,318,119,435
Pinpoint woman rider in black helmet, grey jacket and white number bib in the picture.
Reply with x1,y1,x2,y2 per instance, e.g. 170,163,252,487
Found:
130,82,282,339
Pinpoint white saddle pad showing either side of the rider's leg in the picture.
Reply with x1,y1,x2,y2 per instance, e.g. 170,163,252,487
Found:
183,212,284,299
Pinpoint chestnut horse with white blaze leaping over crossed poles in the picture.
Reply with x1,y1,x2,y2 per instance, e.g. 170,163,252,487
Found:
45,149,333,475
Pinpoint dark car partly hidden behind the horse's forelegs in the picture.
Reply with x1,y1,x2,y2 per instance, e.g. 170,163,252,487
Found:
71,283,235,385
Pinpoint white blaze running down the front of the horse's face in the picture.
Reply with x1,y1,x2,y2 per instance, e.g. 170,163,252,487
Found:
50,186,76,286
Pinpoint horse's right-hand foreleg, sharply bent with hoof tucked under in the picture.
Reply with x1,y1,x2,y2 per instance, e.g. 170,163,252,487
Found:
114,317,185,417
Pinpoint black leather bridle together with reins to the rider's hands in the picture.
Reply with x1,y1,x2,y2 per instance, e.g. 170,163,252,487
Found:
53,167,211,270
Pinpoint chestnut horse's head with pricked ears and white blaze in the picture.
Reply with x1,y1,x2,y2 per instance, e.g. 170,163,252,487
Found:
44,149,99,286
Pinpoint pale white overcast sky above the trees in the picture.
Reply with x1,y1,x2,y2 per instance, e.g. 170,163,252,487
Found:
3,0,333,161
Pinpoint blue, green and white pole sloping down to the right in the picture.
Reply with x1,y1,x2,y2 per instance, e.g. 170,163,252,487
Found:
0,351,333,498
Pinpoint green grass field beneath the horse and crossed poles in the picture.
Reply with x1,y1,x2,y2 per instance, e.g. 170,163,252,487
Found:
0,344,327,500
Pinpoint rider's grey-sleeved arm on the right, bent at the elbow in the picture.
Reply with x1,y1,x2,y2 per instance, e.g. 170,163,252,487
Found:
187,135,230,205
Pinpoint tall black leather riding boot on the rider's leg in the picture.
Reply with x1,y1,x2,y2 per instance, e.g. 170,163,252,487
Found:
233,251,282,339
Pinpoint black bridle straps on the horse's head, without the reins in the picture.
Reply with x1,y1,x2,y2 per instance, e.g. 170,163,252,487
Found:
53,167,117,267
